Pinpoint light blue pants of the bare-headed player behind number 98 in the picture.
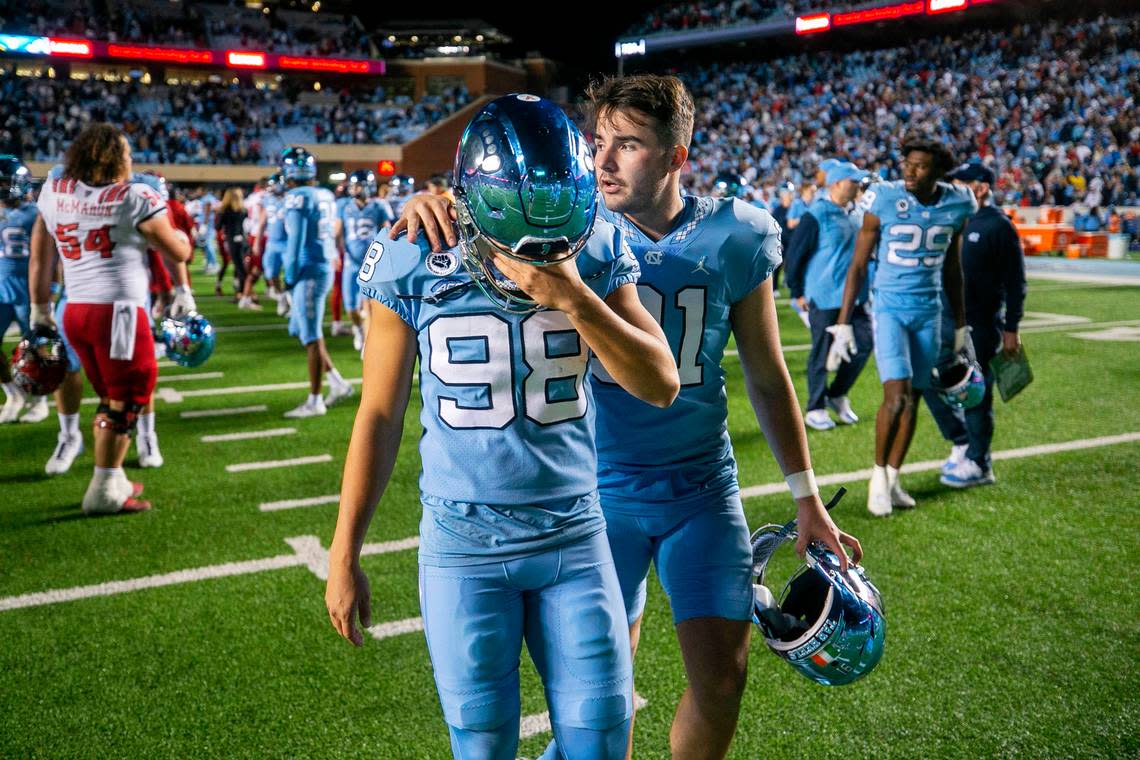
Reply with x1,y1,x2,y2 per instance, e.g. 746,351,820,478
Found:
599,460,752,624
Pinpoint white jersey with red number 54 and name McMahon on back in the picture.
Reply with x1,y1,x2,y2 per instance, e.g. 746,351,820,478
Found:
36,177,166,307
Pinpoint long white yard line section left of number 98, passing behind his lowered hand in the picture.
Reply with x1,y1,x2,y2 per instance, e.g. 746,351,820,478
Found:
0,536,420,612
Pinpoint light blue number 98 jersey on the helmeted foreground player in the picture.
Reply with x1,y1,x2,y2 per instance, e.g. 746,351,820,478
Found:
357,216,637,563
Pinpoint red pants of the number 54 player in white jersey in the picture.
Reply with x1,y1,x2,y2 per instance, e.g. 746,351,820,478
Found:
63,302,158,406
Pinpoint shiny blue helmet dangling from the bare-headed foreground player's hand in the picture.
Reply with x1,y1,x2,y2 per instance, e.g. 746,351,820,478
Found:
752,489,887,686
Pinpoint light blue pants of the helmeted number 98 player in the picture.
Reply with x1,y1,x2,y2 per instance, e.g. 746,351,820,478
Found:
420,533,633,730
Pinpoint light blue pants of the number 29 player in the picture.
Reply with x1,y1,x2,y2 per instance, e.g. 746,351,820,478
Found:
871,309,942,391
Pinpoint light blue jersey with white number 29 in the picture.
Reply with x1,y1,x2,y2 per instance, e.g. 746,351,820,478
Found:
860,180,978,308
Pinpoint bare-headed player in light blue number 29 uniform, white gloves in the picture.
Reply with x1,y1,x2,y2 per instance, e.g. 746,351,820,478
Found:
828,138,977,516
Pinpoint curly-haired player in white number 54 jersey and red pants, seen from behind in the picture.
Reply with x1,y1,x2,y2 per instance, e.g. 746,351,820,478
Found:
31,123,190,514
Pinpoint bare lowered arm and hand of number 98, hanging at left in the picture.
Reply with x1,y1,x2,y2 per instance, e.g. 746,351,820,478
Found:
325,305,416,646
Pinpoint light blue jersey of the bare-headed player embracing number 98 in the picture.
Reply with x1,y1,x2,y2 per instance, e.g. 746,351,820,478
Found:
592,196,782,476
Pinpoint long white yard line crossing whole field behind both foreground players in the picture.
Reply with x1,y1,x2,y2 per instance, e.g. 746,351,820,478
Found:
0,432,1140,612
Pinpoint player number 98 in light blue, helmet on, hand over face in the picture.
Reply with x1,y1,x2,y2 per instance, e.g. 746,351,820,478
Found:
326,95,678,760
